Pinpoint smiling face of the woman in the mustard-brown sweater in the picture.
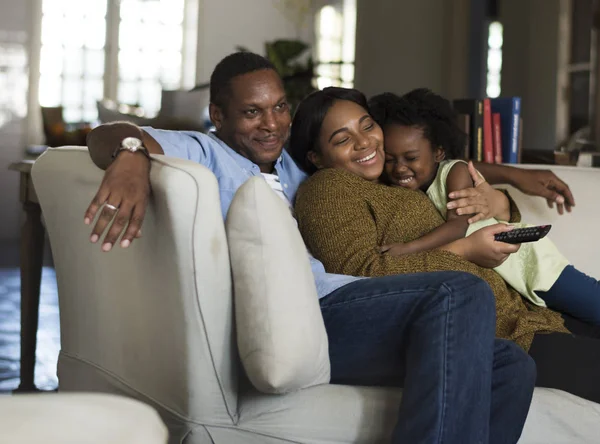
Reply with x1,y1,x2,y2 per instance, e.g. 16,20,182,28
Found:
308,100,384,181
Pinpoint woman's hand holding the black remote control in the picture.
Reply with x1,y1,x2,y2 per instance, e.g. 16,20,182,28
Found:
442,224,520,268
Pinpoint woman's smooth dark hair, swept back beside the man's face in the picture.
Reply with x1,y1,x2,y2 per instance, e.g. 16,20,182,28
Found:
288,86,369,174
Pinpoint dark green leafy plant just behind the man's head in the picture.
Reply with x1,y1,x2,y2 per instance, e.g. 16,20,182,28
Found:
237,39,315,111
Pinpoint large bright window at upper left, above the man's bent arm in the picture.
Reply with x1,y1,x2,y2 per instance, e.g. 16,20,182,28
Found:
39,0,196,122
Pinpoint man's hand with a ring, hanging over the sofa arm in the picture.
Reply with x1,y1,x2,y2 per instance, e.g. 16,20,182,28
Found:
84,152,150,251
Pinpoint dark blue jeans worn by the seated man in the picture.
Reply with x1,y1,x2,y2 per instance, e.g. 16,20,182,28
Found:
321,272,536,444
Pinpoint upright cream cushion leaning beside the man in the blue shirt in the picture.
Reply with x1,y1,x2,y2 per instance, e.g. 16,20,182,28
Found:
226,177,330,393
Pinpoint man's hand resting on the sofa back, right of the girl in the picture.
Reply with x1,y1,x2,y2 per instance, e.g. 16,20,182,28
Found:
512,169,575,214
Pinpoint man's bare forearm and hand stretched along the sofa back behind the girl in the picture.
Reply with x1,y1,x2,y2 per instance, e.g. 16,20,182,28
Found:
475,162,575,214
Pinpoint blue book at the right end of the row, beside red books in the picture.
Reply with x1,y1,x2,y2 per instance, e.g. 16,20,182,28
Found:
491,97,521,163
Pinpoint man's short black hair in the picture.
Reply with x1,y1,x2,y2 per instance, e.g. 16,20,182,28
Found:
210,51,275,108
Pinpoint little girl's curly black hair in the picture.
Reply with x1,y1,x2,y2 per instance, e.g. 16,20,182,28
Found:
369,88,467,159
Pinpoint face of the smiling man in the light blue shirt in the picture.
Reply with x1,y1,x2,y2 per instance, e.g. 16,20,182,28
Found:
210,69,291,173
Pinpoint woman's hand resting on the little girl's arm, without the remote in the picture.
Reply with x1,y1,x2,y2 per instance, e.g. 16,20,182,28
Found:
446,162,510,224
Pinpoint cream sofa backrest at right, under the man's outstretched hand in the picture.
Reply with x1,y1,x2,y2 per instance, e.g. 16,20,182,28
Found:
500,165,600,279
